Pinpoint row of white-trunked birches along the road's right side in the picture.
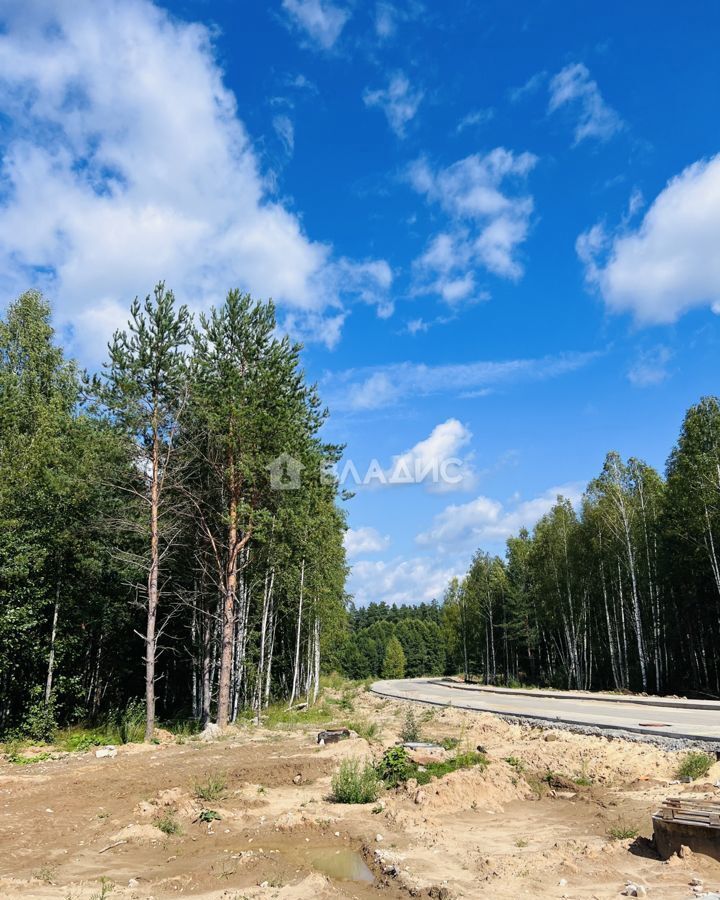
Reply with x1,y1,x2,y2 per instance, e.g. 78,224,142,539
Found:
443,397,720,696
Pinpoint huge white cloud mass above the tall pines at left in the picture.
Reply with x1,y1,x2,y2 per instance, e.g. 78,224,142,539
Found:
0,0,387,362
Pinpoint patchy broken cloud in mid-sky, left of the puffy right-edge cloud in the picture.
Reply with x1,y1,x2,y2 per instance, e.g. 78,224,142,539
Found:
409,147,537,303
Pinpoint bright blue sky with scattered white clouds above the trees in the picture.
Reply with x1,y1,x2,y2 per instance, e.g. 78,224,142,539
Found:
0,0,720,603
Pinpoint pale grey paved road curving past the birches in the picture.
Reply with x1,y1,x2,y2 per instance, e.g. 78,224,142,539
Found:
371,678,720,749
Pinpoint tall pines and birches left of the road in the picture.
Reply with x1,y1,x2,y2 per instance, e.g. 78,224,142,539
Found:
0,284,346,739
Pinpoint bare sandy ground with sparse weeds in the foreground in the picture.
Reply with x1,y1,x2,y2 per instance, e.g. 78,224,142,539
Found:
0,693,720,900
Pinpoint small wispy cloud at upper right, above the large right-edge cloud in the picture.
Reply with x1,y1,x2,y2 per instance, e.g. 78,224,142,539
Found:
548,63,624,144
